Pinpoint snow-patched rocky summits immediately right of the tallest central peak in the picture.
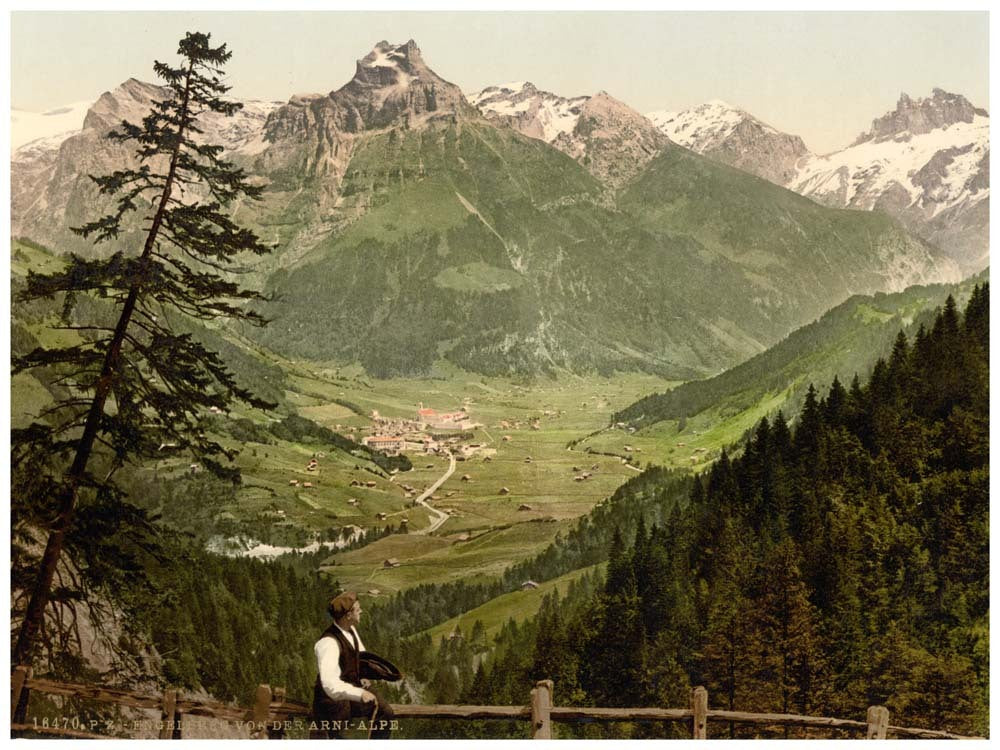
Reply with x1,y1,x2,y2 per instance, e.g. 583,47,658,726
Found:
469,82,667,188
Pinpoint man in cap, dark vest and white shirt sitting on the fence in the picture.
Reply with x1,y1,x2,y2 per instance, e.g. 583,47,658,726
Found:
312,591,393,740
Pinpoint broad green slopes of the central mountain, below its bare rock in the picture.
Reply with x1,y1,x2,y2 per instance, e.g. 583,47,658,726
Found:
264,122,957,378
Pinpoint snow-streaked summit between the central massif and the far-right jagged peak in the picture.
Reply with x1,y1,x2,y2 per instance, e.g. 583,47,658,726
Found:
646,99,809,185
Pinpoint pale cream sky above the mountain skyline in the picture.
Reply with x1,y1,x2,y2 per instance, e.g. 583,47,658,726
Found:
10,11,989,153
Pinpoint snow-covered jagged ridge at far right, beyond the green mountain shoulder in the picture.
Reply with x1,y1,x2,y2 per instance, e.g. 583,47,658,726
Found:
649,89,989,273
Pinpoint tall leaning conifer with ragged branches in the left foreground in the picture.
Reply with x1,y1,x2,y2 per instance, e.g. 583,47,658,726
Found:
12,33,269,664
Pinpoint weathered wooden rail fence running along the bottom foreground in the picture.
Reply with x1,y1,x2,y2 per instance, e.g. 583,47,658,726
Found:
10,666,983,740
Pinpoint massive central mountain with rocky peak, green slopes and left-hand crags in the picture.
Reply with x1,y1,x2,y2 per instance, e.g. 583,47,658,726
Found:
7,41,955,378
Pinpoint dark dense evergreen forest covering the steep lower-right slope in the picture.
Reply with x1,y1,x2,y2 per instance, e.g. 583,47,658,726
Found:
390,285,989,737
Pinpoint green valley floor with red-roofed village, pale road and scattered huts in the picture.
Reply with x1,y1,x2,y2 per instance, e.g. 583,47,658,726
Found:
189,362,728,597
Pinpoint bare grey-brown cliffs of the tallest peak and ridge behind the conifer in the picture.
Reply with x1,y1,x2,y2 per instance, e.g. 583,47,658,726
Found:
12,40,481,262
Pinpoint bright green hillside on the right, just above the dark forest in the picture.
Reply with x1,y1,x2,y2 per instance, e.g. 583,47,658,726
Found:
574,273,986,471
